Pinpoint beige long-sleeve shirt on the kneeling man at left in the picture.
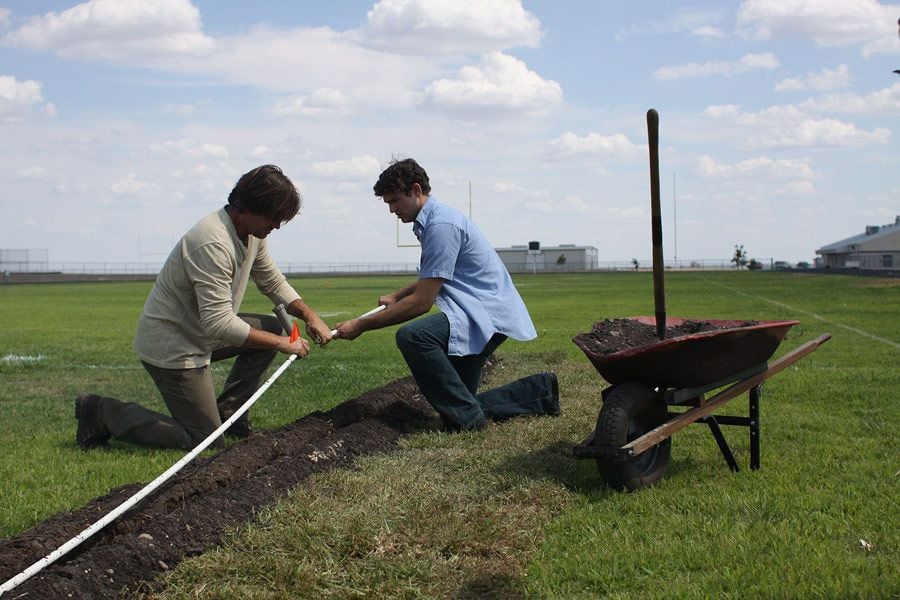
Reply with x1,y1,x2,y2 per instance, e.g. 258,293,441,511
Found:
134,208,300,369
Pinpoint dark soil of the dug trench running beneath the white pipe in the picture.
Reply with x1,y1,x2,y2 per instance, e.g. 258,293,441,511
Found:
0,377,440,598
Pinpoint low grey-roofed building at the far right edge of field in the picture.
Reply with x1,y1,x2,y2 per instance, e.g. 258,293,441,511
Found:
816,216,900,271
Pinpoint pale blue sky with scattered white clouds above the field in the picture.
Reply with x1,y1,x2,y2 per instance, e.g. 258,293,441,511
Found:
0,0,900,264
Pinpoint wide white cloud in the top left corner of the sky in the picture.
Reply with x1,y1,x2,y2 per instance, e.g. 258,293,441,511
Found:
3,0,214,62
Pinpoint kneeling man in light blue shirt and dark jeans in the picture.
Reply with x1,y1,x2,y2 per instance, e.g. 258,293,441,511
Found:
335,159,559,431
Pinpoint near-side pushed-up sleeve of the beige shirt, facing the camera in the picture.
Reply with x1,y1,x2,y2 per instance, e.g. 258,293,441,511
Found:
184,243,250,346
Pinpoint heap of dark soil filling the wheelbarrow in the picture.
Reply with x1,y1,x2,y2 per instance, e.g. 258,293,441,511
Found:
576,319,758,354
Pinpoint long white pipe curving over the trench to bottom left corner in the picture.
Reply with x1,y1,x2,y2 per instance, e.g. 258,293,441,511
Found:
0,354,297,596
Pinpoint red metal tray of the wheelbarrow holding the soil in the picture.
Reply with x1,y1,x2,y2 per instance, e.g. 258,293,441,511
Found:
572,317,799,388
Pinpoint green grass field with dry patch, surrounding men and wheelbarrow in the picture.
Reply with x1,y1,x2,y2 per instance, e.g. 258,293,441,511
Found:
0,272,900,598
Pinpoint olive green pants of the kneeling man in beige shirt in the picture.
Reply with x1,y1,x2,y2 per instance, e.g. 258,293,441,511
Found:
98,314,282,450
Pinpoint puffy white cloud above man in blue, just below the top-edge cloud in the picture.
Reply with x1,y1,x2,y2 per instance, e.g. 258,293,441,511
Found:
425,52,563,113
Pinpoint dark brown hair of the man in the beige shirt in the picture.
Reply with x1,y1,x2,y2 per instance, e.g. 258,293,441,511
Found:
228,165,302,222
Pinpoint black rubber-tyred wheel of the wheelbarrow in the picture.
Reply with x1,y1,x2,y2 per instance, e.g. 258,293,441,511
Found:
594,382,672,491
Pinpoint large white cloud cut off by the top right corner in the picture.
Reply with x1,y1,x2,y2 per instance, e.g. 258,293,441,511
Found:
737,0,900,53
